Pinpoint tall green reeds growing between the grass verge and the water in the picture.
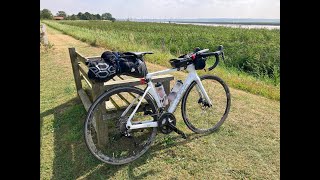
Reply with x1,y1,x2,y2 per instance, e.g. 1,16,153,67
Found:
61,21,280,84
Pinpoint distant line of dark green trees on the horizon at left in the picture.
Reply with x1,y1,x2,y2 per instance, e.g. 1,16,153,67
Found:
40,9,116,22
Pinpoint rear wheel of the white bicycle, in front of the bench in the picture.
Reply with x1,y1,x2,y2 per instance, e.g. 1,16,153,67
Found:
84,87,157,165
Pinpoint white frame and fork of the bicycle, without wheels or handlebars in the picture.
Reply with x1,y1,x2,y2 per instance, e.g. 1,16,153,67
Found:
125,64,212,129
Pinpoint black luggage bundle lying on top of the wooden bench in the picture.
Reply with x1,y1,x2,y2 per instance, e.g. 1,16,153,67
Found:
87,51,148,82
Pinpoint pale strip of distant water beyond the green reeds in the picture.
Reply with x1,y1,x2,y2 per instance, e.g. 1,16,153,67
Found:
122,18,280,29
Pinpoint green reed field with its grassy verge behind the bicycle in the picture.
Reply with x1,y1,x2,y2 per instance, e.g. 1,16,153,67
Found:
45,21,280,100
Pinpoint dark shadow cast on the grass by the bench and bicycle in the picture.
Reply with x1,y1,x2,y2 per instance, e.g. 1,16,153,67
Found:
40,98,212,179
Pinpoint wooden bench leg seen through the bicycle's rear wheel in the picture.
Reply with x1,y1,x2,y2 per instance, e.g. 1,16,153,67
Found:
92,82,108,147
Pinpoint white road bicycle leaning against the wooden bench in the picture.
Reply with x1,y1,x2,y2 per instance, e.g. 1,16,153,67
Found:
84,45,231,165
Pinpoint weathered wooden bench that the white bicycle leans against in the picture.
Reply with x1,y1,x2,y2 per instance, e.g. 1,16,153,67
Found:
69,48,174,146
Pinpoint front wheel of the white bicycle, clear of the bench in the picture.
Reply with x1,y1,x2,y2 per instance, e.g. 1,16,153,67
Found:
181,75,231,133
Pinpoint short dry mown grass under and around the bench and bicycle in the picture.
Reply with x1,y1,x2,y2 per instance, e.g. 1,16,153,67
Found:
40,23,280,180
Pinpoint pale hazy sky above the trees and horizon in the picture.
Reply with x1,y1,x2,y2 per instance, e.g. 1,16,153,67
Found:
40,0,280,19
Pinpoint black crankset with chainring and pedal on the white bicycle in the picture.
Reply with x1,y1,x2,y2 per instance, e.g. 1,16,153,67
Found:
158,112,187,139
